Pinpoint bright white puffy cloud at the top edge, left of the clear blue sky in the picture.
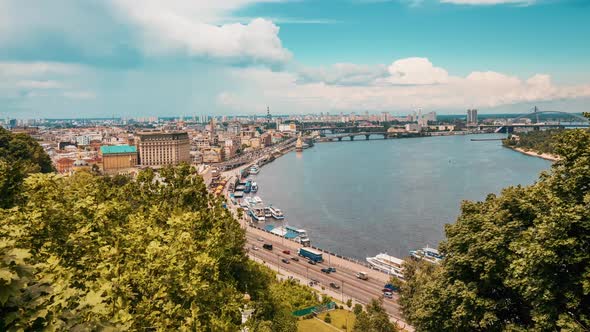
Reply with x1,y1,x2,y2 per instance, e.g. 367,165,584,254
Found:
113,0,291,63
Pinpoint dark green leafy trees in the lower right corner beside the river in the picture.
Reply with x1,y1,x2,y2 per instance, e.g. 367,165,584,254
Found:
400,130,590,331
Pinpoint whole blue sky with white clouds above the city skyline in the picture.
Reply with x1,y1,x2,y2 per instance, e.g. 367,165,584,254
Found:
0,0,590,118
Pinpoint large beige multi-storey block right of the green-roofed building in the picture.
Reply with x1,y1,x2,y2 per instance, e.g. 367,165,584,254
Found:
136,131,191,166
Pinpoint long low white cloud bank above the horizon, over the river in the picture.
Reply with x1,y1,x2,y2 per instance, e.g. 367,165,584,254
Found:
218,58,590,113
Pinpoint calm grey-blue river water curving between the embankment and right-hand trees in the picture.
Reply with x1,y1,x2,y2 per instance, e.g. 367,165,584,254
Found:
255,135,551,260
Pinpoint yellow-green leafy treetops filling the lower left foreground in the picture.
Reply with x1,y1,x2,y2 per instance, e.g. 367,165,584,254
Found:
0,147,317,331
